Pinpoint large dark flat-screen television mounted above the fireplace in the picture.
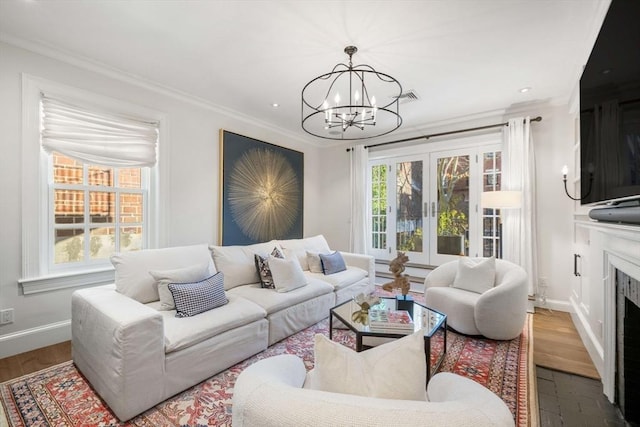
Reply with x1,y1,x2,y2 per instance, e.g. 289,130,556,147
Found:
580,0,640,205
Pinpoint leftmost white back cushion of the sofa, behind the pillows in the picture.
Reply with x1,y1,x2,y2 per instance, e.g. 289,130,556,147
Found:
111,244,215,304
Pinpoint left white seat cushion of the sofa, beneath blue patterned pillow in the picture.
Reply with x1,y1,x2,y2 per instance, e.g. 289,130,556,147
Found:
158,291,268,353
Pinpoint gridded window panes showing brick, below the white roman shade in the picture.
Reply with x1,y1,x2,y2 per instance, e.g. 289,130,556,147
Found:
47,152,148,270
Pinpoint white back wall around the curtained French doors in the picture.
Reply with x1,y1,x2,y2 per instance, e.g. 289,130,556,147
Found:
320,104,574,311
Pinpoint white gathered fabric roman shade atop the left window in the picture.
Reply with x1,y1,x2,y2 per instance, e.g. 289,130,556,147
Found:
41,95,158,167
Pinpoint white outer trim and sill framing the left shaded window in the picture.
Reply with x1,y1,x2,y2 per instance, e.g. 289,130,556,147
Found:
18,74,168,295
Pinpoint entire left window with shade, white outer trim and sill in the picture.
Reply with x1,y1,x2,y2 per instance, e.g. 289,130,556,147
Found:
19,74,168,295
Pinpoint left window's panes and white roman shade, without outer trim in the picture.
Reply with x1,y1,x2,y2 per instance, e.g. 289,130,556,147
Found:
41,94,158,271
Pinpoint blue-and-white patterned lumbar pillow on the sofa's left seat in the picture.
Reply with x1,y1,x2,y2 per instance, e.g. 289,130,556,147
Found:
169,272,229,317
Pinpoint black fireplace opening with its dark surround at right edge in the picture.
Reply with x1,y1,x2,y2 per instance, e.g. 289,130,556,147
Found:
615,269,640,425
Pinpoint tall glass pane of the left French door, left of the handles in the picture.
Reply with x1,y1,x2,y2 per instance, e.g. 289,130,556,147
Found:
396,161,423,252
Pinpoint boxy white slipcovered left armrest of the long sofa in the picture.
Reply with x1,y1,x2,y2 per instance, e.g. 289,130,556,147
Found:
71,285,164,420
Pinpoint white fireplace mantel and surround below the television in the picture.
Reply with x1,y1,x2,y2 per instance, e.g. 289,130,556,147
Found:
570,217,640,425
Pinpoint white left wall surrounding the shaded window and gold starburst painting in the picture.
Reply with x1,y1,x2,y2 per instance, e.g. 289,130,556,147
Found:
0,43,323,358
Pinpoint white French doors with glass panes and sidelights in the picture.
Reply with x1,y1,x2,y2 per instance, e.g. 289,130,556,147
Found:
369,144,501,265
